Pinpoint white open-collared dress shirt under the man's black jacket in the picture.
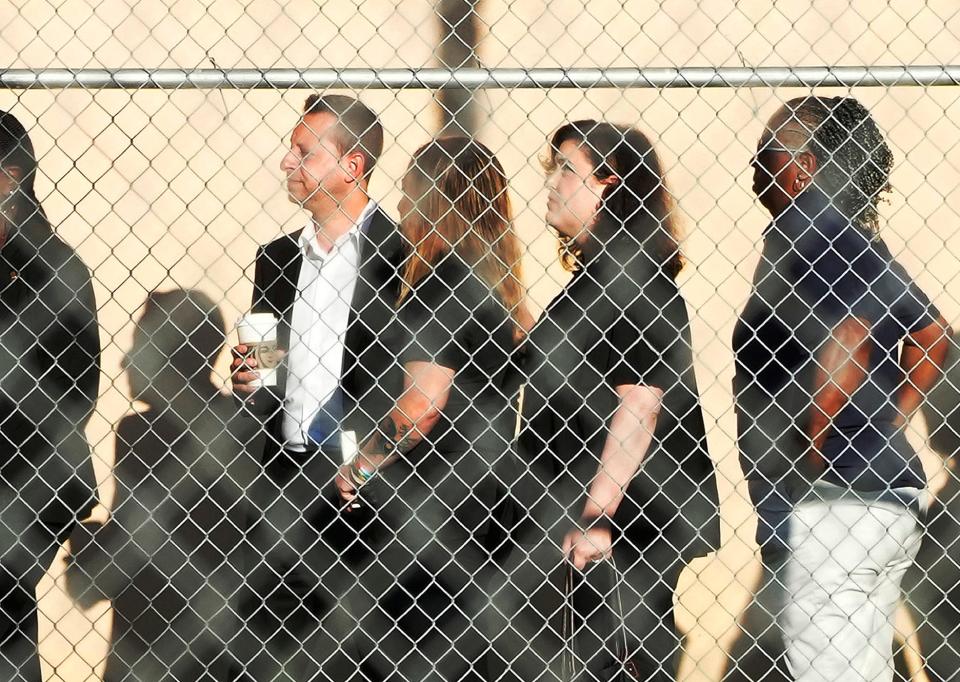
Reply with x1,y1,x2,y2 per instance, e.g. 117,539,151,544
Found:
282,200,377,452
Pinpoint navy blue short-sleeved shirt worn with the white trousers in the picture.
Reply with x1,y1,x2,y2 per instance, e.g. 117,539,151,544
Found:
733,189,939,491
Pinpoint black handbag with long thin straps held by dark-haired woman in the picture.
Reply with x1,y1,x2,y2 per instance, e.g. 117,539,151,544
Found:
560,556,642,682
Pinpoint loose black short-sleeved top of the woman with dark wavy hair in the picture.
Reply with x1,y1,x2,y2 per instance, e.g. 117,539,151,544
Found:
516,243,720,558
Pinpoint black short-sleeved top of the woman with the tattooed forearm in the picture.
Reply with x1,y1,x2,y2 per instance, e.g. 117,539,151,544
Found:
384,254,520,518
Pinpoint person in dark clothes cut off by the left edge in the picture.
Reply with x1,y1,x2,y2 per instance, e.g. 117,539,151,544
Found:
0,112,100,680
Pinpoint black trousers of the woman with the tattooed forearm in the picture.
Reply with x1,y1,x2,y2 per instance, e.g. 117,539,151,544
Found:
351,463,496,682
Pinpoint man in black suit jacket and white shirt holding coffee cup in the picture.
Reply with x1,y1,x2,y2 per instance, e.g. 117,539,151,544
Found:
233,95,403,680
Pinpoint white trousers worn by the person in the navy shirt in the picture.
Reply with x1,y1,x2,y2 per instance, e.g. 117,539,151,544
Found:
782,486,925,682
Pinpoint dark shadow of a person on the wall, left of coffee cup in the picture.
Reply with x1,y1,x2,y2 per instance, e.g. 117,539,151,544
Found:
68,290,252,681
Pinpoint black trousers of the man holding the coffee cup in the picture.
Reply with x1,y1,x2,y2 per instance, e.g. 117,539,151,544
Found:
231,451,374,682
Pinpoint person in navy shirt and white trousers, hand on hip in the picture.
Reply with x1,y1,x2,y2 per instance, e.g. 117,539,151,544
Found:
733,96,951,681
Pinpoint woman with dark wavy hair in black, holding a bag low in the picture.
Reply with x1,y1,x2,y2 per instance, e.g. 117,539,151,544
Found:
493,120,719,681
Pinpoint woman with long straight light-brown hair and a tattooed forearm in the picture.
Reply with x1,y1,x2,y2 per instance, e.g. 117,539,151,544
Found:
337,137,532,682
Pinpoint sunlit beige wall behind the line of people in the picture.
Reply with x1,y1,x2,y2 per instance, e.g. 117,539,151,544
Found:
0,0,960,682
